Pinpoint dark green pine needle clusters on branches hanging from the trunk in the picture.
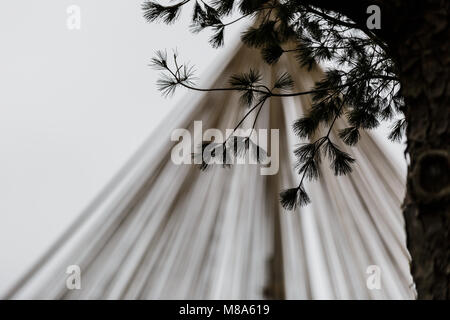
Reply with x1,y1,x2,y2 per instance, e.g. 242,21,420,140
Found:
142,0,406,210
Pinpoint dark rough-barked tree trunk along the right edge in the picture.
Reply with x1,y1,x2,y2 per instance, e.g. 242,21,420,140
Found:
390,0,450,299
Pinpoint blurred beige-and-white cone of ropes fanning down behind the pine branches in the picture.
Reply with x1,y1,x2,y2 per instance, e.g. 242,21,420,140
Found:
5,46,415,299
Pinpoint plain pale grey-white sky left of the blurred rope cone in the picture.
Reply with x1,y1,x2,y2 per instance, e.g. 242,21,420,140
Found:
0,0,401,294
